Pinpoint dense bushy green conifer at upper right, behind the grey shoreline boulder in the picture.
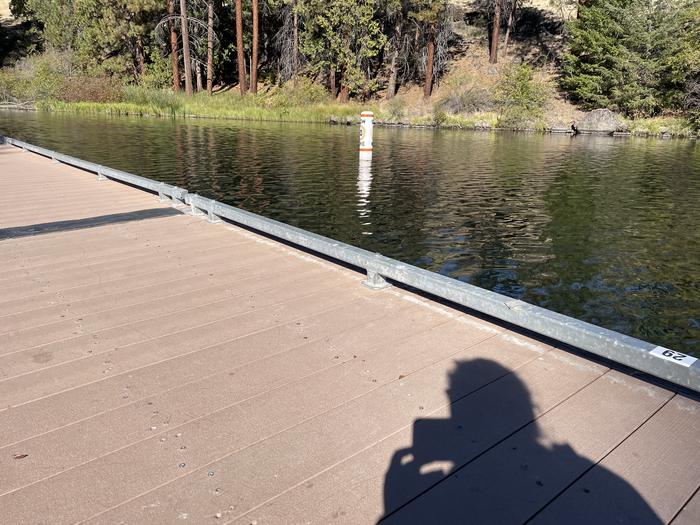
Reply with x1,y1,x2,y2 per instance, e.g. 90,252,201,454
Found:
562,0,697,116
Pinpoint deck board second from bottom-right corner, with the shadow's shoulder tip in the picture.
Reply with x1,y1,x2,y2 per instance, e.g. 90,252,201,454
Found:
535,396,700,524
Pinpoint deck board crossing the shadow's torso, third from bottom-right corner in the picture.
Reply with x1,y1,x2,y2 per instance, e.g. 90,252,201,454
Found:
388,372,672,523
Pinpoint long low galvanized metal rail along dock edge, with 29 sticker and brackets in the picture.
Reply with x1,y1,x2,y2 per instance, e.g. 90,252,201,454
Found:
4,137,700,392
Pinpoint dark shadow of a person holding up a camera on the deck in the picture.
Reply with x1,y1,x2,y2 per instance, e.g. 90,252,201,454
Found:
379,359,661,525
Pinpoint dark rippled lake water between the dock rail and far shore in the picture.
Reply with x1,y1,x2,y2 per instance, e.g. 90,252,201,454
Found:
0,112,700,356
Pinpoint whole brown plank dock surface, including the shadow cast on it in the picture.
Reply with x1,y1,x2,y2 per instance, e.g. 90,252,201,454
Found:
0,146,700,524
